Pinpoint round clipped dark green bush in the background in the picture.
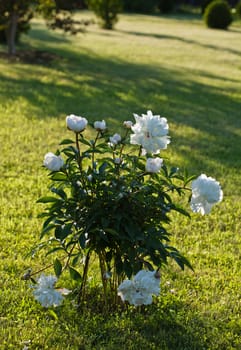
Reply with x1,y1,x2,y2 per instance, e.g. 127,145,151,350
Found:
204,0,232,29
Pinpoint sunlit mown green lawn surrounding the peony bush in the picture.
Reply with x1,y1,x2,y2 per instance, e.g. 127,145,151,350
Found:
0,13,241,350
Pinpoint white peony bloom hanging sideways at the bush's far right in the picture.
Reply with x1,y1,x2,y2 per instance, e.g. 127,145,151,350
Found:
191,174,223,215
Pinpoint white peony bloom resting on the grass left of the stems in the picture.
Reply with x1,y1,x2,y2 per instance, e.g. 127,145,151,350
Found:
33,274,64,307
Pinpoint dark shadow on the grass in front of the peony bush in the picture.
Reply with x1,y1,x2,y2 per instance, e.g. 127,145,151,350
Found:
48,292,207,350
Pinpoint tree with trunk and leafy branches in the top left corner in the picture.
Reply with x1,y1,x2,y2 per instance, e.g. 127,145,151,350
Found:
0,0,88,55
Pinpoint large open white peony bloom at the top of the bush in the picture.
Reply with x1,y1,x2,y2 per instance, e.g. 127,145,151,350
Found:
130,111,170,154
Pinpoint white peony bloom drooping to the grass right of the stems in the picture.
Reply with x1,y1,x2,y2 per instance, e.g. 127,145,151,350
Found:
118,270,160,306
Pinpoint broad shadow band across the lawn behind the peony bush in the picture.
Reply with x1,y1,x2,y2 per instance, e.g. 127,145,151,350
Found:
0,39,241,176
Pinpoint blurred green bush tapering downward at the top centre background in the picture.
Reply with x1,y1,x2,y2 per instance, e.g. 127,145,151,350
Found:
88,0,122,29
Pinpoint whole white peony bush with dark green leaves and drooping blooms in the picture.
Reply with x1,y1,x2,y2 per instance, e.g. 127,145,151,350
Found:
29,111,223,308
